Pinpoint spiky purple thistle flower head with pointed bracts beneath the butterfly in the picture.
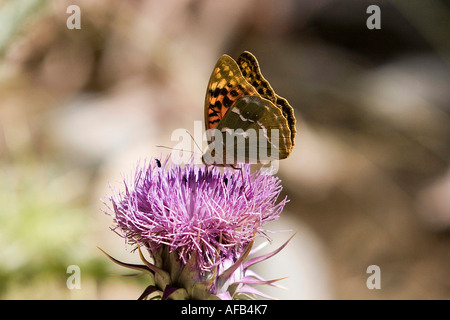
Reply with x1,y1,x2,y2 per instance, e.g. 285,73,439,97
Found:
102,158,296,300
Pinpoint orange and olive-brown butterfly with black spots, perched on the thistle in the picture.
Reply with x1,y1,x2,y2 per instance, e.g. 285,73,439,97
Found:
202,51,296,168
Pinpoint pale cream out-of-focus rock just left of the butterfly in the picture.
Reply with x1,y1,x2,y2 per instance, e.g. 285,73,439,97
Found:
43,81,161,164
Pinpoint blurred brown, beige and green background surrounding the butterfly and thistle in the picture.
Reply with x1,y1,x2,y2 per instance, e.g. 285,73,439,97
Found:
0,0,450,299
